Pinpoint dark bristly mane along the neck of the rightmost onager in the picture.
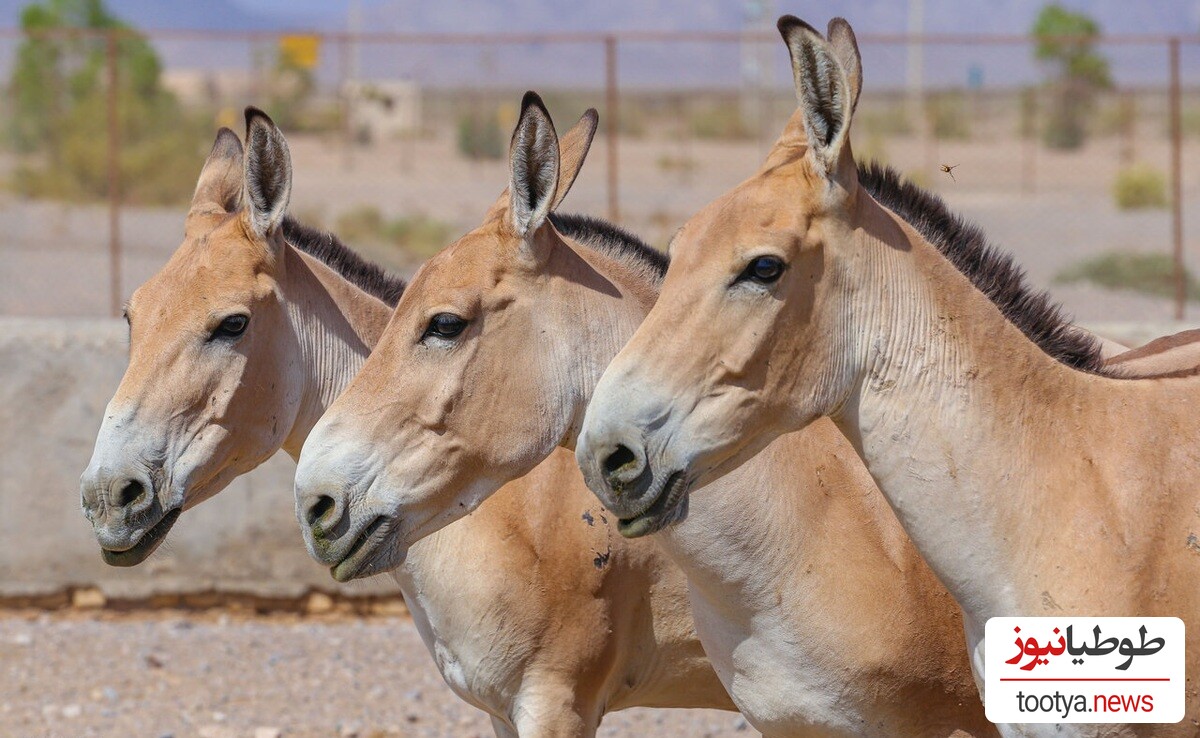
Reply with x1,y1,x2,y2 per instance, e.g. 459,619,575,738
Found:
858,162,1109,374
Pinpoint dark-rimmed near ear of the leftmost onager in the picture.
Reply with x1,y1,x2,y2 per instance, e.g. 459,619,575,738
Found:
245,107,292,239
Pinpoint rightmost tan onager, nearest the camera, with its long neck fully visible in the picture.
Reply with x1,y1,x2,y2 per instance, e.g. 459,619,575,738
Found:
576,17,1200,737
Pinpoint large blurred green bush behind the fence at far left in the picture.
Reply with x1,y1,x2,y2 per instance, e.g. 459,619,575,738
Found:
8,0,211,204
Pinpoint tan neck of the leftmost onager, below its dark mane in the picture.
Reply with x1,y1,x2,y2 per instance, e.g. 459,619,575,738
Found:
283,246,392,458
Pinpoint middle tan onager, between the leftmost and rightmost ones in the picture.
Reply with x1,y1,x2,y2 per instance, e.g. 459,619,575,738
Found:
296,94,995,738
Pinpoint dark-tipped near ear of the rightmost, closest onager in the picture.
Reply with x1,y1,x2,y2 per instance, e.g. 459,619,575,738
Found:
779,16,853,173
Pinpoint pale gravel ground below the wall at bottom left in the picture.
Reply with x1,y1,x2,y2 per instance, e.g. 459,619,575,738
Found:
0,612,757,738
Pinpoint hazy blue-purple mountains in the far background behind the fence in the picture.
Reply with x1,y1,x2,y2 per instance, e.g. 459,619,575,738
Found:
0,0,1185,89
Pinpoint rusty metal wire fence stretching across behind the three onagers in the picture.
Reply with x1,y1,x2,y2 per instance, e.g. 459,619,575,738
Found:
0,30,1200,320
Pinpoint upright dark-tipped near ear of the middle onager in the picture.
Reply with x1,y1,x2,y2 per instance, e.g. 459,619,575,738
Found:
509,92,559,238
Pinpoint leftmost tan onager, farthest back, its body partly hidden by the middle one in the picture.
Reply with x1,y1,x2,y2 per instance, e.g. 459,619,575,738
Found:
82,112,733,737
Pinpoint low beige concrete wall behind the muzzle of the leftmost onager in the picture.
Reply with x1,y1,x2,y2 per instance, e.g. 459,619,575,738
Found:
0,318,397,599
